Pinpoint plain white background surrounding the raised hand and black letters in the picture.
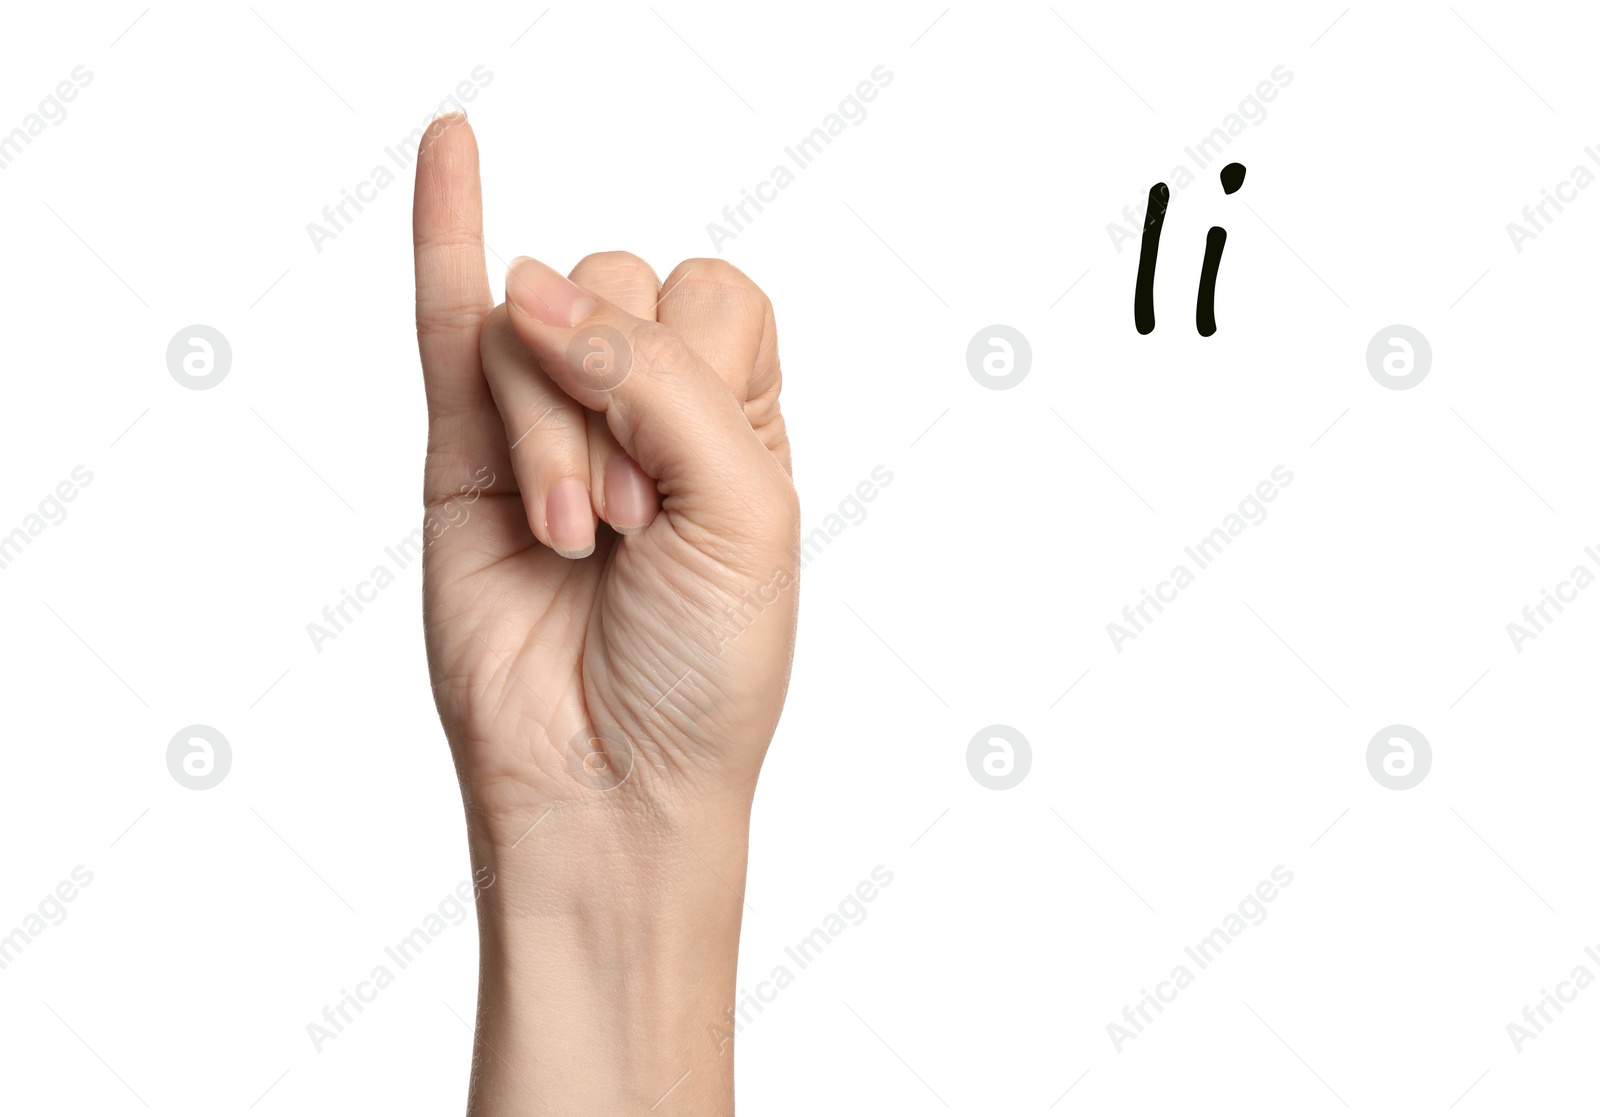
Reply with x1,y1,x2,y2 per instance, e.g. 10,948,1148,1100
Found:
0,0,1600,1115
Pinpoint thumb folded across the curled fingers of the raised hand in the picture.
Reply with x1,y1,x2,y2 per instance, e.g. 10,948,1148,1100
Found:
506,256,797,546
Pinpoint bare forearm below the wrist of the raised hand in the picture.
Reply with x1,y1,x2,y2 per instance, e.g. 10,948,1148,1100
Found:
469,810,747,1117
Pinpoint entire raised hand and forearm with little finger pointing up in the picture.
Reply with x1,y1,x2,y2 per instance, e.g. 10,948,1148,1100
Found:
414,117,798,1117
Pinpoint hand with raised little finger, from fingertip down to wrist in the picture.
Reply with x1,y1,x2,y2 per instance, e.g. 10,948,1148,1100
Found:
416,118,798,839
